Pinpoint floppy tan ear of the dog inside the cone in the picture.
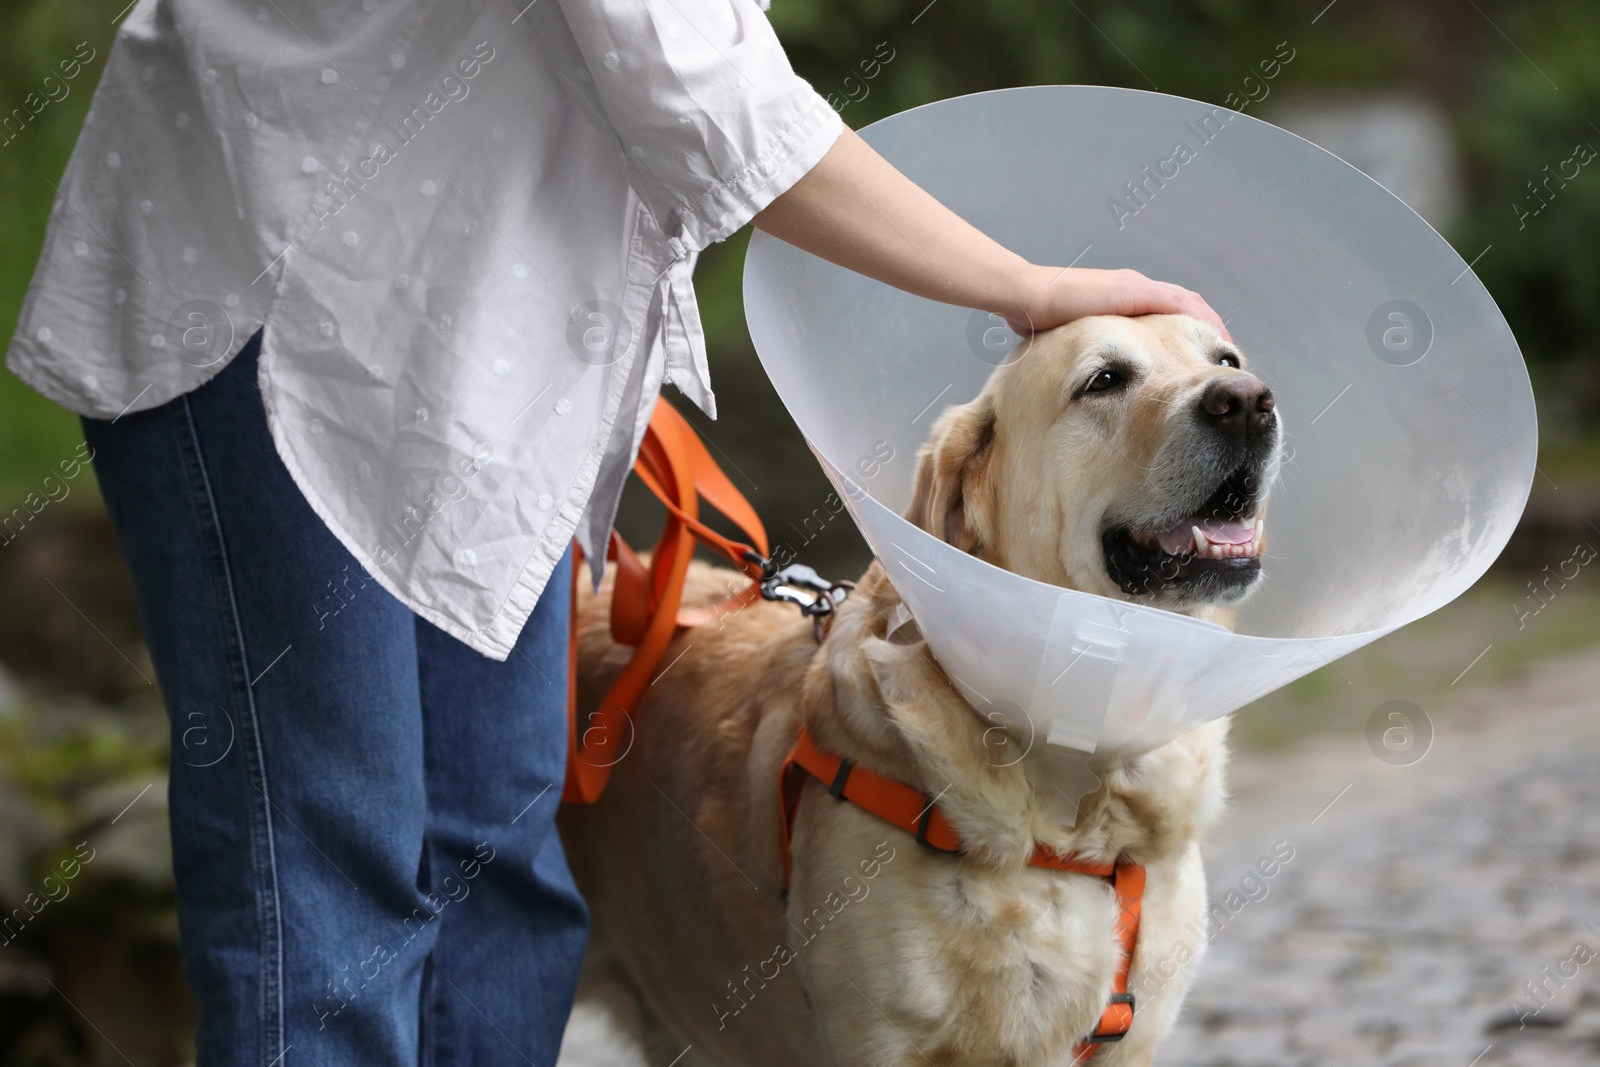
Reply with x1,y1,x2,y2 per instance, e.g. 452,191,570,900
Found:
906,394,995,552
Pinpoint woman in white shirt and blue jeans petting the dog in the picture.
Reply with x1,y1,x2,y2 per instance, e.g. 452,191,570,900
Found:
8,0,1221,1067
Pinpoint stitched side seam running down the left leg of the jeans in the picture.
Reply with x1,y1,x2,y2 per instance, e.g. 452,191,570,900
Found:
179,394,286,1064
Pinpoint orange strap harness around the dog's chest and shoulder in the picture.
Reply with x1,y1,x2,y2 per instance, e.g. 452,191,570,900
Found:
778,726,1144,1061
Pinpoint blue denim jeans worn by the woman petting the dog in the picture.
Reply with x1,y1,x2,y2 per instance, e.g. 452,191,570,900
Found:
83,333,589,1067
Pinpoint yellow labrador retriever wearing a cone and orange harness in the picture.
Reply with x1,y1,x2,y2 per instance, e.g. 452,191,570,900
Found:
562,315,1282,1067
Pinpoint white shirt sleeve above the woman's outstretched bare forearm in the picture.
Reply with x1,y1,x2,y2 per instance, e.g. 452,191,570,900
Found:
541,0,843,251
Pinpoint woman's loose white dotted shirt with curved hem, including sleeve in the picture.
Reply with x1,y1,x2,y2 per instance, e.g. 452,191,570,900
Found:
8,0,843,659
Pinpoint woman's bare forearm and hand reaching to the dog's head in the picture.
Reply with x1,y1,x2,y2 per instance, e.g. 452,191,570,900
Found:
752,128,1227,338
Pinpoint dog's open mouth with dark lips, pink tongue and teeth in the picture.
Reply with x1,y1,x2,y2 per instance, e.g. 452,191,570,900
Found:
1101,464,1264,603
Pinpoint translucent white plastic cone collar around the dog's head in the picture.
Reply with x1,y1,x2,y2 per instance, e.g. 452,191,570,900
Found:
744,86,1538,764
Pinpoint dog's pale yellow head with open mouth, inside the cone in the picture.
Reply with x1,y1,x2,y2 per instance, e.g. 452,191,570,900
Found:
906,315,1283,614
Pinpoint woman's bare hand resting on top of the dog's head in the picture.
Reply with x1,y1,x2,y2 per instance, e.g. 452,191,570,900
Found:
989,264,1232,341
